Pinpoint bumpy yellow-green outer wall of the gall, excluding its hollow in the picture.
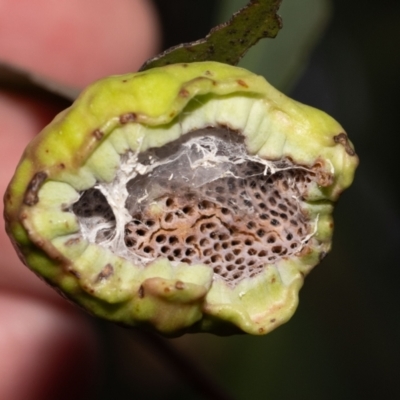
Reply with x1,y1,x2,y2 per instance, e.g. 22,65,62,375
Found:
4,62,358,336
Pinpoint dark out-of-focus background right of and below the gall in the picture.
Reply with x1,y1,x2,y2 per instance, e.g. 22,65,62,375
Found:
3,0,400,400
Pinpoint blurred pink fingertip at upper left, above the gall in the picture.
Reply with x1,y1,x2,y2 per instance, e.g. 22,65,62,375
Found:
0,0,160,87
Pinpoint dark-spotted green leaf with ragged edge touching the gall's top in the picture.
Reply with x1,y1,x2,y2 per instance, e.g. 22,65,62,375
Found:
141,0,282,71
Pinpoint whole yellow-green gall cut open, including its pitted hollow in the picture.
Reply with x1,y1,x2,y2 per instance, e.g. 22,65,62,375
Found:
4,62,358,336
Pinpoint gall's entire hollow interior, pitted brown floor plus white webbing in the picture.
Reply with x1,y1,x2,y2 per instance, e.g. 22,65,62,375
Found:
72,131,321,286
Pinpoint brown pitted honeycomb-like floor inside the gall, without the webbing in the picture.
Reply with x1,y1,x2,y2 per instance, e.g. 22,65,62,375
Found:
125,162,314,285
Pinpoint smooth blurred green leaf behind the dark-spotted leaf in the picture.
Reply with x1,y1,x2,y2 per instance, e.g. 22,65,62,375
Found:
219,0,333,92
